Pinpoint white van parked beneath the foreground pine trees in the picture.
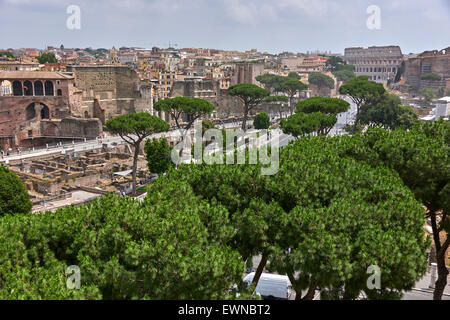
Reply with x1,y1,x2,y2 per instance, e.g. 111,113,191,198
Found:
244,272,293,300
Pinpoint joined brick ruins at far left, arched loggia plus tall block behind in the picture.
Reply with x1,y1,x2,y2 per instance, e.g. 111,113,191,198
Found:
0,66,153,150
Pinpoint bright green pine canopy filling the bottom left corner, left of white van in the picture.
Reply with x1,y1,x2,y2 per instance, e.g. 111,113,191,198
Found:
0,189,244,300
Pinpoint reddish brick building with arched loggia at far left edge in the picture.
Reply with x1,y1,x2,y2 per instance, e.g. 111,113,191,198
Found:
0,71,102,150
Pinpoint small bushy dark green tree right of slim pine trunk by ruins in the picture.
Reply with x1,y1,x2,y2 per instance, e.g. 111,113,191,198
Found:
144,138,175,175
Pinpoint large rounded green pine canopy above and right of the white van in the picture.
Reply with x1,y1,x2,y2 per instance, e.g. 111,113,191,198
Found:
156,132,428,299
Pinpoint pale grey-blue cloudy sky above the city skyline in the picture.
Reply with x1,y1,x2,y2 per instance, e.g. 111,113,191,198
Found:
0,0,450,53
